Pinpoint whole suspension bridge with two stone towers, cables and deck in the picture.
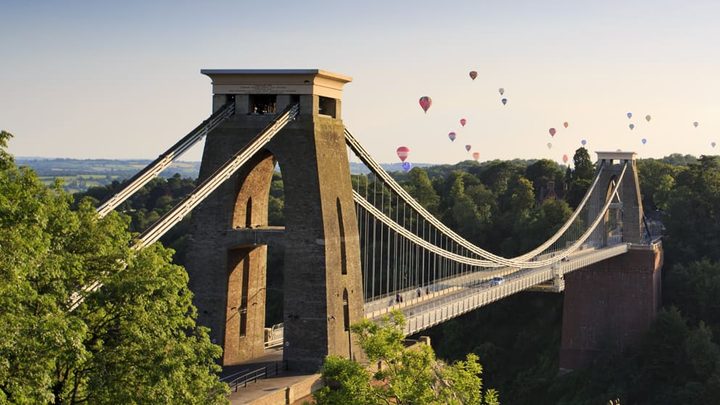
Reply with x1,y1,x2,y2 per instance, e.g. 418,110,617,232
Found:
77,70,662,371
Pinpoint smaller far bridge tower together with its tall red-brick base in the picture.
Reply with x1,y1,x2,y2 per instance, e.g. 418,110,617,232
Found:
560,152,663,369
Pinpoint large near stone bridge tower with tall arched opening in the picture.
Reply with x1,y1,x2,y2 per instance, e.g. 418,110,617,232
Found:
187,70,364,371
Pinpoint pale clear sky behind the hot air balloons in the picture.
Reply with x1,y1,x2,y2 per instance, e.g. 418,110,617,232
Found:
0,0,720,163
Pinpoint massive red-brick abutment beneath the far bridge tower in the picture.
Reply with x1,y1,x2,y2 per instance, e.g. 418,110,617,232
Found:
560,243,663,370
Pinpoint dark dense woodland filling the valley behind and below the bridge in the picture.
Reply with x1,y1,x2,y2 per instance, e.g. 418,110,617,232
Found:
5,124,720,404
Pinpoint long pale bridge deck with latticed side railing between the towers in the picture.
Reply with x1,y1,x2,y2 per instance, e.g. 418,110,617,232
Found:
365,243,630,335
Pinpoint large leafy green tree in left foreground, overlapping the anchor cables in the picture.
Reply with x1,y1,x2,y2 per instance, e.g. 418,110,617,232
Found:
0,132,227,404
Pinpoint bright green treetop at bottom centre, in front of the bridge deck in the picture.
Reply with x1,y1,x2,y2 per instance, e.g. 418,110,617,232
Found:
314,311,499,405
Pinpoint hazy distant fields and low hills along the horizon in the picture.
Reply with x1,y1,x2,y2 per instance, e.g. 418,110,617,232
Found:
15,157,432,193
